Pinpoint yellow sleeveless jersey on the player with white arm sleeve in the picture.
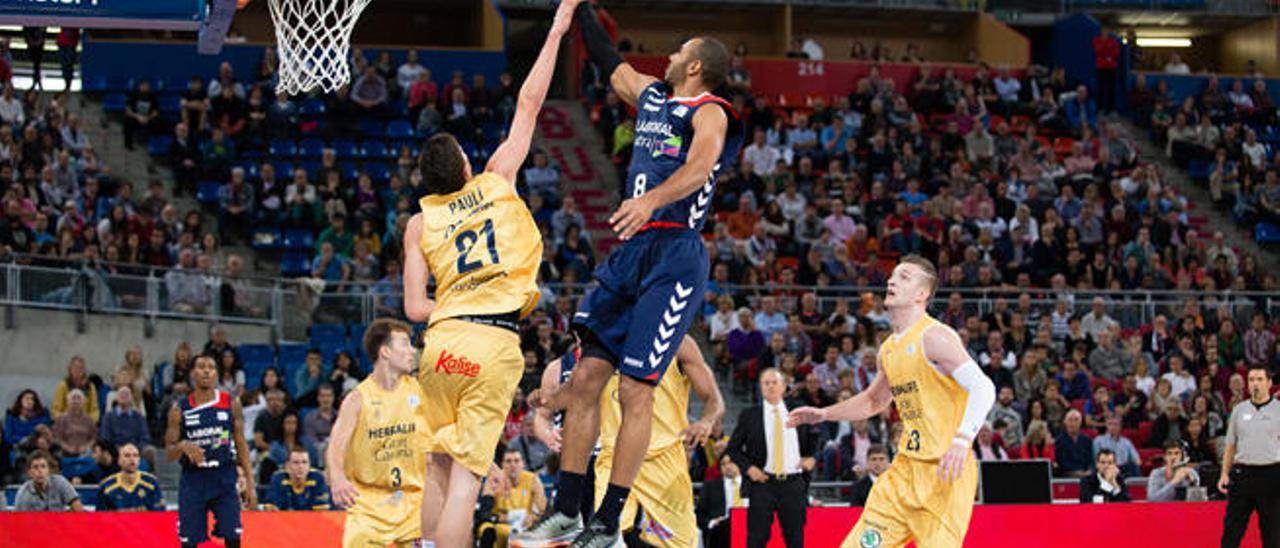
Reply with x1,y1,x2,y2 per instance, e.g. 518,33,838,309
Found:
879,314,969,461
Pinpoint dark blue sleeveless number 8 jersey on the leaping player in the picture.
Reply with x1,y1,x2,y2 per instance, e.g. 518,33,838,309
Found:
623,81,742,230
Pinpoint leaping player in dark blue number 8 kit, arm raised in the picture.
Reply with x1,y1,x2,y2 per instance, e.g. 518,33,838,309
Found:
512,3,742,548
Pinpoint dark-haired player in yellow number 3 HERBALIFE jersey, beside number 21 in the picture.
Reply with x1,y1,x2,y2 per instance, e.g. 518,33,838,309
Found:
325,319,426,548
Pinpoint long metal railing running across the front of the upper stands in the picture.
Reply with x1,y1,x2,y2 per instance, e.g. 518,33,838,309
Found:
0,256,1280,341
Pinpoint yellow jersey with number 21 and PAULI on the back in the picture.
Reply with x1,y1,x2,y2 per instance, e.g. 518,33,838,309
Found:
419,173,543,324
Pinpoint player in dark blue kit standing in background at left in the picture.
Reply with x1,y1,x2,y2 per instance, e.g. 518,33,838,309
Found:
164,356,257,548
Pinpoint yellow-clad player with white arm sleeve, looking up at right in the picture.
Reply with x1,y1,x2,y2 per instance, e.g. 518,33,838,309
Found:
788,255,996,548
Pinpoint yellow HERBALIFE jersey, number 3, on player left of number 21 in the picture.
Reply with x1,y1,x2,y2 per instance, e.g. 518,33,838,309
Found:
344,375,429,526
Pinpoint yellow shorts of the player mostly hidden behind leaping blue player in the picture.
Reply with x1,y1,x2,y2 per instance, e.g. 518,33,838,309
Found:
595,443,699,548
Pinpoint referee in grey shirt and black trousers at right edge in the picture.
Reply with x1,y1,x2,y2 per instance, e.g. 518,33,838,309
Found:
1217,365,1280,548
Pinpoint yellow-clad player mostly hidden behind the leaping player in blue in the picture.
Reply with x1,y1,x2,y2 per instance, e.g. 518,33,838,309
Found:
532,335,724,547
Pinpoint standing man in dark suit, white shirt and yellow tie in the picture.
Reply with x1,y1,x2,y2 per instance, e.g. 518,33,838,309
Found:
726,369,818,548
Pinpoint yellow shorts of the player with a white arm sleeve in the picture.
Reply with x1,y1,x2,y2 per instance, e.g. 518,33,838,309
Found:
841,456,978,548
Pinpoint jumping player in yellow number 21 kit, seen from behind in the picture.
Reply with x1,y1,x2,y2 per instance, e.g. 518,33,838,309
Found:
404,0,580,548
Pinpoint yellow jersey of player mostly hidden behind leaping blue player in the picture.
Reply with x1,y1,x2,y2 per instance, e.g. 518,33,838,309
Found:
600,360,690,456
